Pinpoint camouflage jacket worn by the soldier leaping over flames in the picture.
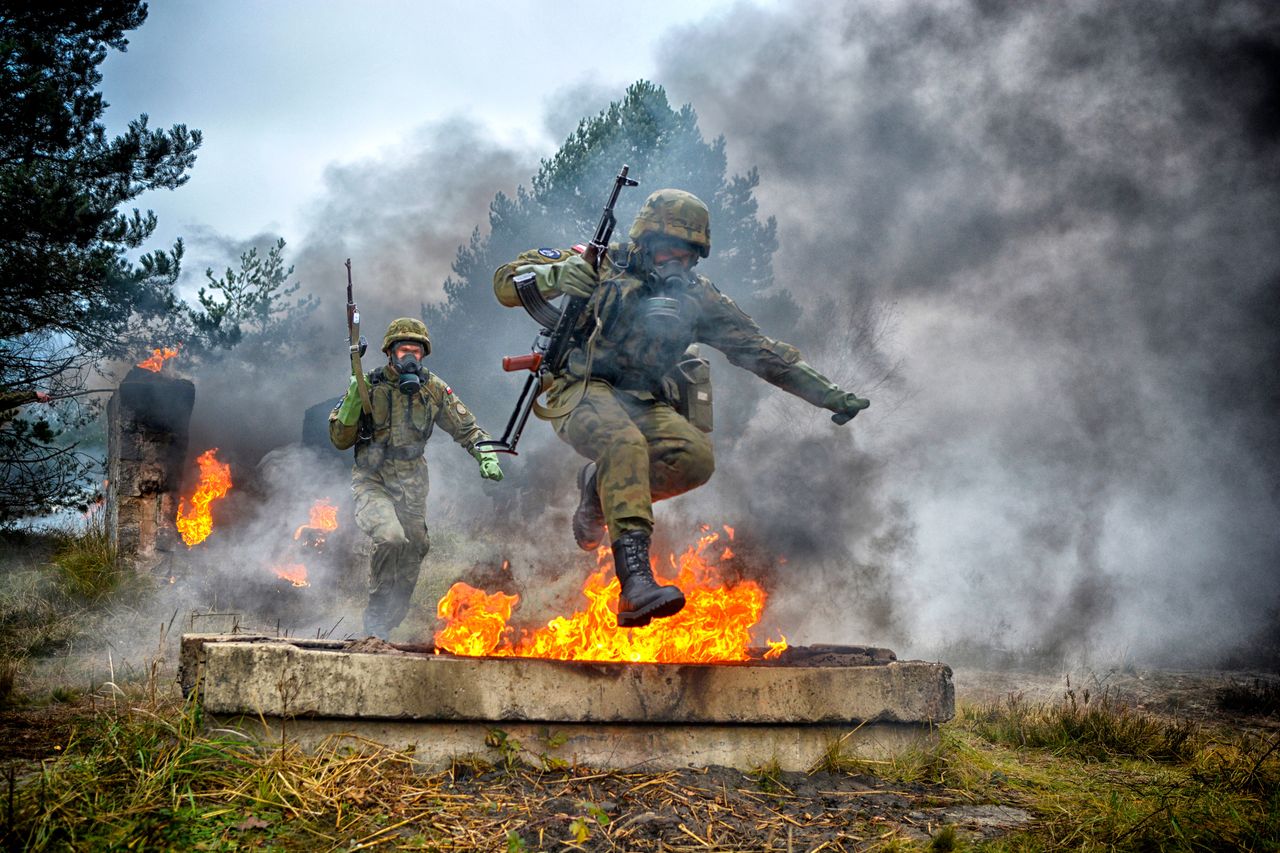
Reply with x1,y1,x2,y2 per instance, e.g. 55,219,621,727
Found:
494,248,829,406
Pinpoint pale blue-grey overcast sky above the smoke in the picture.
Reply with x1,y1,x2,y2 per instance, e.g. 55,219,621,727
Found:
102,0,774,258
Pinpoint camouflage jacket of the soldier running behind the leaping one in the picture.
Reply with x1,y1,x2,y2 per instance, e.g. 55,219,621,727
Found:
329,365,489,467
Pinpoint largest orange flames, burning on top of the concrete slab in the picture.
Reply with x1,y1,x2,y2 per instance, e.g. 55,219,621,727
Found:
435,526,787,663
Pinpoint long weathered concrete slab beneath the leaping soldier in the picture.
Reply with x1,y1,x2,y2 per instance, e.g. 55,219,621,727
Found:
182,635,955,770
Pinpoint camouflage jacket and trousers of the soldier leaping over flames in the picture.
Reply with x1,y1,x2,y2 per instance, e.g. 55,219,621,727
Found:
494,250,842,537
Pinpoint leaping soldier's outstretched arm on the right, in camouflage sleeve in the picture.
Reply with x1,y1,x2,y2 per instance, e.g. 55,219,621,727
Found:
698,282,872,424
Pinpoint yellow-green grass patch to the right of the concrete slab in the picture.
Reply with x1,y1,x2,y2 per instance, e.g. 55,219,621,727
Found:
947,689,1280,850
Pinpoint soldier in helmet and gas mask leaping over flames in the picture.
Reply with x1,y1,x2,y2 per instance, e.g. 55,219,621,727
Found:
494,183,870,628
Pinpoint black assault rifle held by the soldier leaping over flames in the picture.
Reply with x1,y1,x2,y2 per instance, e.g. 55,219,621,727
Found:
476,165,640,456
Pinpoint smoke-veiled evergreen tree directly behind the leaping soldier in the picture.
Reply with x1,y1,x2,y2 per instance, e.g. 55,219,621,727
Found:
422,81,799,432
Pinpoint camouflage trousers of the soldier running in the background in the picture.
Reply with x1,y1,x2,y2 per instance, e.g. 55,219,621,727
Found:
351,459,431,630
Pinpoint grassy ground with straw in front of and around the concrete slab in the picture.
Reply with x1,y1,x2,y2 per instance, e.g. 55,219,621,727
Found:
0,532,1280,850
